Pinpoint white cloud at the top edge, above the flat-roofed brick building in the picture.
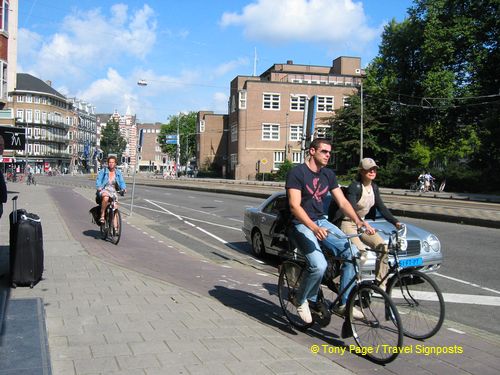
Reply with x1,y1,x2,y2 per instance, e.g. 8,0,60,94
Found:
220,0,380,45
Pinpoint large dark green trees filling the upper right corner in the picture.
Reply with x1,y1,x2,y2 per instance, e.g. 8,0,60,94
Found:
330,0,500,191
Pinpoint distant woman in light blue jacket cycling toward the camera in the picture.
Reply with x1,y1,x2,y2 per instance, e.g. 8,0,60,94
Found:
95,155,127,224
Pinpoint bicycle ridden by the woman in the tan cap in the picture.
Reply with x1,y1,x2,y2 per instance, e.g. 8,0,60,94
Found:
371,225,445,340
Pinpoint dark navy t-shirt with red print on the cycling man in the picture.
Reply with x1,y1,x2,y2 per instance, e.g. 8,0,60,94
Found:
285,164,339,221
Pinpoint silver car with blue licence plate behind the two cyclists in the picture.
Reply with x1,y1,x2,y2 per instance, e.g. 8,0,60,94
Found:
242,192,443,278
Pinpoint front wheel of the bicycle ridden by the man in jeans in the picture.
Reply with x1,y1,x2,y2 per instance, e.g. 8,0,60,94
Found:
346,284,403,364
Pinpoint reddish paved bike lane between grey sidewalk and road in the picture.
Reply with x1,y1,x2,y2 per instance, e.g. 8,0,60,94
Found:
49,188,500,374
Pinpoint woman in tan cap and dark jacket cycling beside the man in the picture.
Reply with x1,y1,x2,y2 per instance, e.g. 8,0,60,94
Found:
332,158,401,290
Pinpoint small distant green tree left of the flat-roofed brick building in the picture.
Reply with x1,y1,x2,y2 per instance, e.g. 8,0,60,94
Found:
158,112,196,164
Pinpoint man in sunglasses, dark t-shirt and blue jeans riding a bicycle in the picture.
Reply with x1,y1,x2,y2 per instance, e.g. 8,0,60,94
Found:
285,138,375,323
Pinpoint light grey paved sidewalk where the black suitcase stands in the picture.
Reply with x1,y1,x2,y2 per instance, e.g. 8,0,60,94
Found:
0,184,350,375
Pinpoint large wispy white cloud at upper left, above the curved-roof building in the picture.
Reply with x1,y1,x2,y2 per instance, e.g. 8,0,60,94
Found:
19,5,156,83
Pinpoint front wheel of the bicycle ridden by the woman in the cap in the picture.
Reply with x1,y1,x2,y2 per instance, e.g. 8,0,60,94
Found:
387,269,445,340
